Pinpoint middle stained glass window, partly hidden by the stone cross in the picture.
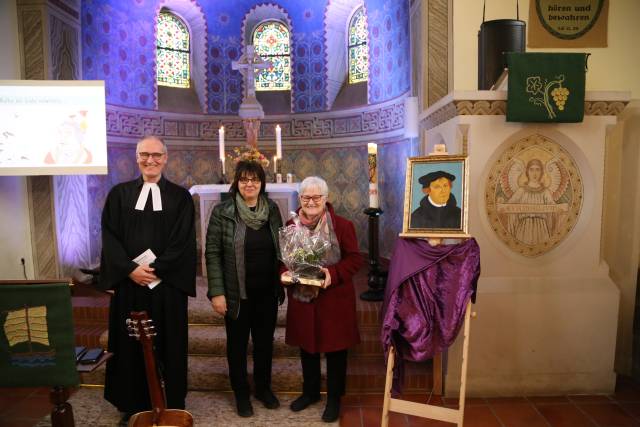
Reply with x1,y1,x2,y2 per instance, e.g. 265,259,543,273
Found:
253,21,291,90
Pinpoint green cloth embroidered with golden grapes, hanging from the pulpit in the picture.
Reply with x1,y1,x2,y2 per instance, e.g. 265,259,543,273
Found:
506,52,589,123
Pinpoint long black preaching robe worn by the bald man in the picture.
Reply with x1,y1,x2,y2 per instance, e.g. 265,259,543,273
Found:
99,177,197,412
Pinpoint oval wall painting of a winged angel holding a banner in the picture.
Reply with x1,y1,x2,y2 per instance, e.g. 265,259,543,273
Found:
485,134,583,257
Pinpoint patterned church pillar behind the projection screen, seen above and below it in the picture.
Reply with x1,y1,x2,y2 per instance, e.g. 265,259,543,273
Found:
17,0,90,278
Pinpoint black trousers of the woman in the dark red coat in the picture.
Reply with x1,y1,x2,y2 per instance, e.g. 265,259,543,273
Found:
300,349,347,398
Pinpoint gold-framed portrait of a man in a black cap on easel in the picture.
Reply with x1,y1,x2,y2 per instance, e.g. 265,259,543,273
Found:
400,155,470,238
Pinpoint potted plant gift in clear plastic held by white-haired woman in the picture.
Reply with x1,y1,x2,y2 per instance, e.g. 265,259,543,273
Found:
278,212,331,286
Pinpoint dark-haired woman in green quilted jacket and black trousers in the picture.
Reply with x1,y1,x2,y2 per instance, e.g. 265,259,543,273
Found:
205,161,284,417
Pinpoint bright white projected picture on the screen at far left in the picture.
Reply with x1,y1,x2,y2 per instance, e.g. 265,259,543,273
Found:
0,81,107,175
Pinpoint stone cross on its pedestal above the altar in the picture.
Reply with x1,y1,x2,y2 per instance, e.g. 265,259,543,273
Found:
231,45,273,147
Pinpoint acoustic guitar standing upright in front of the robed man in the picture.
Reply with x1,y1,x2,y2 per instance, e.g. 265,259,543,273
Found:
127,311,193,427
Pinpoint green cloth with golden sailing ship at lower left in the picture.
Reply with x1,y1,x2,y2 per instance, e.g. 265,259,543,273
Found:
0,282,79,387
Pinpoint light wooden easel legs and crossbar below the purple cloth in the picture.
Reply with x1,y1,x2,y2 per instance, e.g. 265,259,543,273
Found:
381,301,471,427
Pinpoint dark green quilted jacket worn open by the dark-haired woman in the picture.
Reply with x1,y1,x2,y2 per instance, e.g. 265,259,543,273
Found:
205,196,284,319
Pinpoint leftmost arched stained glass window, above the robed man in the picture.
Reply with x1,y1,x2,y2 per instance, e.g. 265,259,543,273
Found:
156,12,189,88
